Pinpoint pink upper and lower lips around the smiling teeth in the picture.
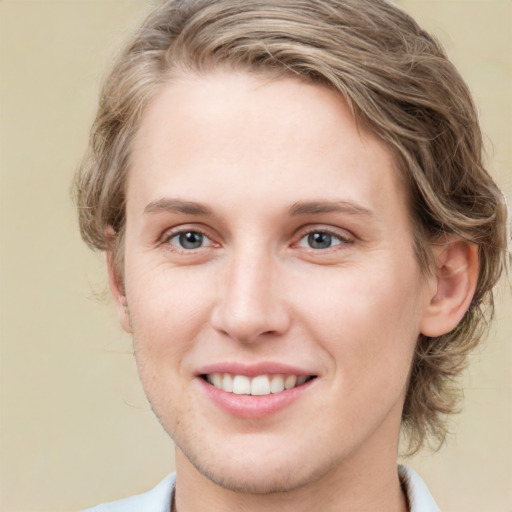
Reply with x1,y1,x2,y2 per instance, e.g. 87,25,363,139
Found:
196,362,318,419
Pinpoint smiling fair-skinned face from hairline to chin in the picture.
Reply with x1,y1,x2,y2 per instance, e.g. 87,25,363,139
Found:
113,71,431,492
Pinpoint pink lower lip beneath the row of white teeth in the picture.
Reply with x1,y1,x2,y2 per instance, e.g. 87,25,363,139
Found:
198,377,317,419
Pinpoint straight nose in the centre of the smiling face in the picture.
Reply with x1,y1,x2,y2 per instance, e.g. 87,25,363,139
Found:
212,245,290,343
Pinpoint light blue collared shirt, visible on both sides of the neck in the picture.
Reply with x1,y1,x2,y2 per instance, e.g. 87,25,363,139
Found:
82,466,441,512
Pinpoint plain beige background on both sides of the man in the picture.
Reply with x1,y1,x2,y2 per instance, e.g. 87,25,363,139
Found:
0,0,512,512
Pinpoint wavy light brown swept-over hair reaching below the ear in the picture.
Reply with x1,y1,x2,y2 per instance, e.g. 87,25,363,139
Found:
74,0,508,453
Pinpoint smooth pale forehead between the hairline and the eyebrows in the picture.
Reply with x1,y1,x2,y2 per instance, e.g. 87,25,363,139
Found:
128,71,408,223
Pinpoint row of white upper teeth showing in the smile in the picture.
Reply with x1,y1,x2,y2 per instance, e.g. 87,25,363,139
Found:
206,373,308,396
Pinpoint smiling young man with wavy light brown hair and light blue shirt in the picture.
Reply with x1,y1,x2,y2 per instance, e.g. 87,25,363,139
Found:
76,0,506,512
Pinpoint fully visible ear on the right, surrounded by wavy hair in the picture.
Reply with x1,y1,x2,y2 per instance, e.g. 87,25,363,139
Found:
421,238,479,337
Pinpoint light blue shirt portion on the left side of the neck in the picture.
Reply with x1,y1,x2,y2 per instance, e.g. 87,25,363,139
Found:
78,473,176,512
